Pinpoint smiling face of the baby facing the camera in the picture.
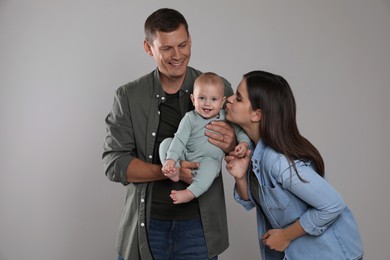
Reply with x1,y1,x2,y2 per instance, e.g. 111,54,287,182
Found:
191,84,226,118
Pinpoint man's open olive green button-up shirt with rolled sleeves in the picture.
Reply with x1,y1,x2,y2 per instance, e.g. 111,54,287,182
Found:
102,67,233,260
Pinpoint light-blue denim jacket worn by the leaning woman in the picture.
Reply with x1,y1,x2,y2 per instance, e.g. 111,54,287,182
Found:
234,140,363,260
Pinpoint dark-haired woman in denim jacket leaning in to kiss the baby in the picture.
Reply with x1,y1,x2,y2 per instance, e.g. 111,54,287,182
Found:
225,71,363,260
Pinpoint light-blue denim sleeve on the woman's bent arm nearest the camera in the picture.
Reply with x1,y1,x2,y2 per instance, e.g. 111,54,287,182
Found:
272,157,345,235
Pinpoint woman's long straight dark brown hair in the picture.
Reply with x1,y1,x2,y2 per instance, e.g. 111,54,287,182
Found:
244,71,325,176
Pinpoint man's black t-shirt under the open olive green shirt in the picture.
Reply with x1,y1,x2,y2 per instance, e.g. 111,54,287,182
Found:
151,92,200,220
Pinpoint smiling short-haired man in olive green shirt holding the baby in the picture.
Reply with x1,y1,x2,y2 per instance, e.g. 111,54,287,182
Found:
103,8,236,260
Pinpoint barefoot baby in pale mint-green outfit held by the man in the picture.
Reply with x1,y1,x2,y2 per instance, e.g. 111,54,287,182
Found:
159,72,250,204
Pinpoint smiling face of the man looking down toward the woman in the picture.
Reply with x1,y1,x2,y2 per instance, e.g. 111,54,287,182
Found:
144,25,191,80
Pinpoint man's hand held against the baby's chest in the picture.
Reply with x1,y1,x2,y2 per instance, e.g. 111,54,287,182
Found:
205,121,237,153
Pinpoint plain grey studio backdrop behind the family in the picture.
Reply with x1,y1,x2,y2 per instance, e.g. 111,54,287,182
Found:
0,0,390,260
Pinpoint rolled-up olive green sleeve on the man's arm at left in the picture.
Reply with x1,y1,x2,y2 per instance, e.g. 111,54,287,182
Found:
102,87,135,185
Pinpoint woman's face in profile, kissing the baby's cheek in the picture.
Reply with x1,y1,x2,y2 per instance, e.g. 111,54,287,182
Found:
226,79,252,129
